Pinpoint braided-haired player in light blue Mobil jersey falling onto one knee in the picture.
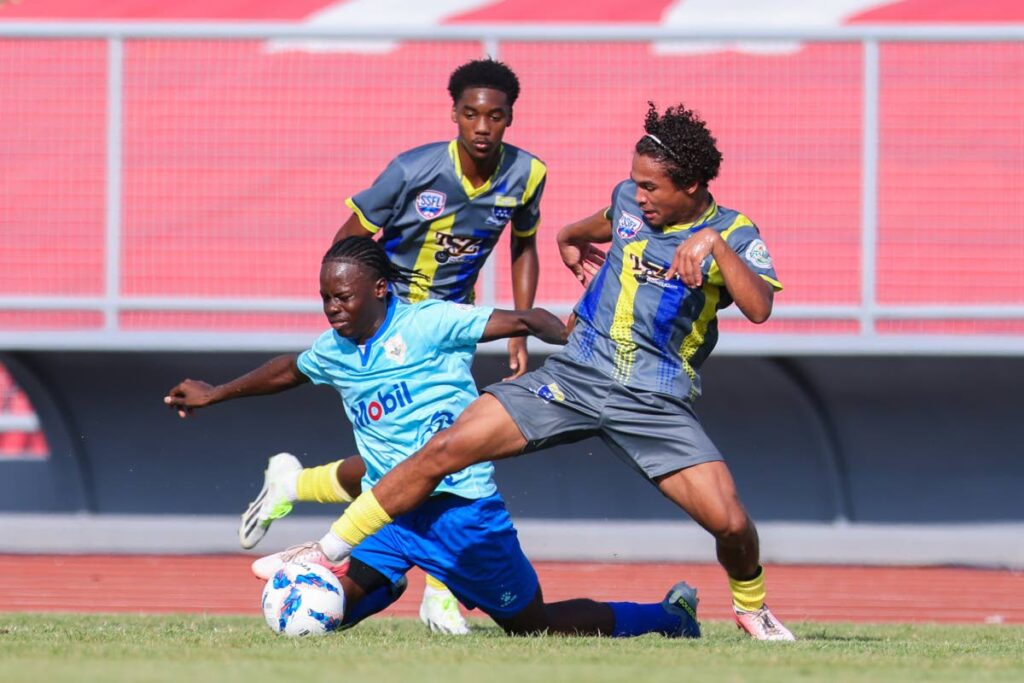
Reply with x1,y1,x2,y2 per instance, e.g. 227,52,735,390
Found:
164,238,700,638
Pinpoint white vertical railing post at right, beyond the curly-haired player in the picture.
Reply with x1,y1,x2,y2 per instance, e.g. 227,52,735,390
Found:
860,39,880,337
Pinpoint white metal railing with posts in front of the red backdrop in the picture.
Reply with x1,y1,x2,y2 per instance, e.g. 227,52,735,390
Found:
6,23,1024,354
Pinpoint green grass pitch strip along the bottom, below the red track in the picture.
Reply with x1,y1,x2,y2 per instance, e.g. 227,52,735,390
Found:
0,613,1024,683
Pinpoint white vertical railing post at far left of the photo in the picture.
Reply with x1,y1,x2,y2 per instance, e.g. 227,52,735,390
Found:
103,37,124,332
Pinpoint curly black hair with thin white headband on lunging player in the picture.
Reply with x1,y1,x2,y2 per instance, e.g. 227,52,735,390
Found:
636,101,722,188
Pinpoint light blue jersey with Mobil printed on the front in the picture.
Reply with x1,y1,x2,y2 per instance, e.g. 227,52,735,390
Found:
298,296,498,499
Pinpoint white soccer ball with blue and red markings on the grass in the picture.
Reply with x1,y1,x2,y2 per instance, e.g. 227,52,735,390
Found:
263,562,345,636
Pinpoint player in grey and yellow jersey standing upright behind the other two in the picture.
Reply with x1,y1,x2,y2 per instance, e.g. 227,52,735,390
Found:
239,59,547,634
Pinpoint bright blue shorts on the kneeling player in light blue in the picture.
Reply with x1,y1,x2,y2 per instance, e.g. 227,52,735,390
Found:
352,494,540,618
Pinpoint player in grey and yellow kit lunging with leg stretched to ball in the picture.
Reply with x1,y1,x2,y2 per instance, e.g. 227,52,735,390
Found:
311,100,793,640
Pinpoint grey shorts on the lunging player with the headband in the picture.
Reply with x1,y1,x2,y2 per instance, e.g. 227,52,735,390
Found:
484,355,723,479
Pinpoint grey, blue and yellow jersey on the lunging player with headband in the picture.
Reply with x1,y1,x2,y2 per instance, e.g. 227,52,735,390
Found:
562,180,782,400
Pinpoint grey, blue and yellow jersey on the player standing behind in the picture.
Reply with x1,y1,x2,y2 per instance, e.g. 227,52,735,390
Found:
345,140,547,302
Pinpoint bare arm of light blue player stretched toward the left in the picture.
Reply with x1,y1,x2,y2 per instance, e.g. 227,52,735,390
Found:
164,355,309,418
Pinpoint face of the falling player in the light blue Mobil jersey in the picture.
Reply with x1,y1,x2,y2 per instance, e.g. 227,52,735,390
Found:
321,261,387,344
